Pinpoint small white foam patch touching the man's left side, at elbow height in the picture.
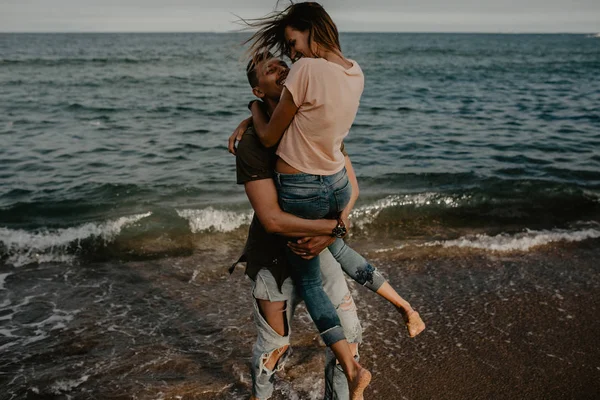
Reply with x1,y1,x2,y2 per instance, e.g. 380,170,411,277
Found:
176,207,252,233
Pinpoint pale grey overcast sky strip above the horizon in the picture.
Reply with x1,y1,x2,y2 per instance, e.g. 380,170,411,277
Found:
0,0,600,32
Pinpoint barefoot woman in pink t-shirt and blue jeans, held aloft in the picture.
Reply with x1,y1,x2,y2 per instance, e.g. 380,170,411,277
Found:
237,3,424,399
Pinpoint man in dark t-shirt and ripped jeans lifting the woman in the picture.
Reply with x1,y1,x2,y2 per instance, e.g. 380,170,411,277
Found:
229,55,362,400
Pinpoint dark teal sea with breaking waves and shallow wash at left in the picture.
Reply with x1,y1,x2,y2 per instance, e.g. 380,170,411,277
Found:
0,33,600,400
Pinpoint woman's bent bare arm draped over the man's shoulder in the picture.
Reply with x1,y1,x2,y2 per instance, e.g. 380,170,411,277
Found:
251,88,298,147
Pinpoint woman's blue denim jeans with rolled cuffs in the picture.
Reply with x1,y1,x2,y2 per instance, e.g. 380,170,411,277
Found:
275,169,384,346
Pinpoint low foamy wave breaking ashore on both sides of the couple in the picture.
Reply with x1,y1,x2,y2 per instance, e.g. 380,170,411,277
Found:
0,186,600,266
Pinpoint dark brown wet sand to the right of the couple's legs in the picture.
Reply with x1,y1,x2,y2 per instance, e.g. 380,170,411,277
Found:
359,241,600,399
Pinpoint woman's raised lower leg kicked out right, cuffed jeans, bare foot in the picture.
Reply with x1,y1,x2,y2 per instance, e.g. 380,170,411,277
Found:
329,239,425,337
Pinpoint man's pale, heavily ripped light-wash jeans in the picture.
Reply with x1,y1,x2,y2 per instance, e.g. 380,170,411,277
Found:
252,250,362,400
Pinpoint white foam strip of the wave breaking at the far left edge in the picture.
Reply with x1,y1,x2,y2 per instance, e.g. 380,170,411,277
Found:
0,212,152,267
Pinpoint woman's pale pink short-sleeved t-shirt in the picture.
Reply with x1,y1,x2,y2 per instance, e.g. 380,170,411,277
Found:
277,58,365,175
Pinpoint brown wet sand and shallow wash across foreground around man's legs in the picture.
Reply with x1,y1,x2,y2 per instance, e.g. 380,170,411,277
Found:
0,240,600,400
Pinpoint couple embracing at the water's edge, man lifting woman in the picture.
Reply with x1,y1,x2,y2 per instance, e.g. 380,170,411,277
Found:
229,2,425,400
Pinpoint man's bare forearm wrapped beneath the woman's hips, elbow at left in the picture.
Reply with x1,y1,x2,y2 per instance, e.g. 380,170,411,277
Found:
244,179,337,237
